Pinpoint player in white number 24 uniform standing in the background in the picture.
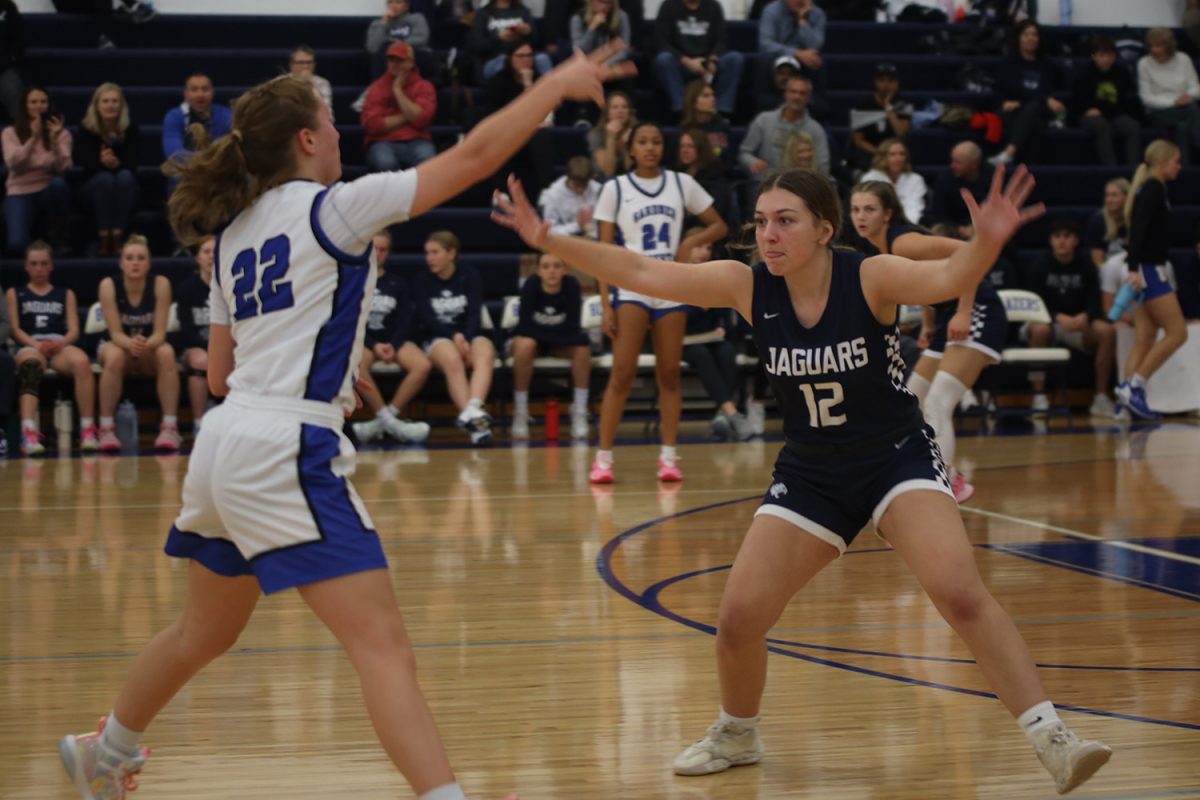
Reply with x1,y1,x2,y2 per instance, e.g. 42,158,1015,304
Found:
588,122,726,483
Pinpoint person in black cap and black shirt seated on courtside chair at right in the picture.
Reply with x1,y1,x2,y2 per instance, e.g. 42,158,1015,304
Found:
1021,218,1116,416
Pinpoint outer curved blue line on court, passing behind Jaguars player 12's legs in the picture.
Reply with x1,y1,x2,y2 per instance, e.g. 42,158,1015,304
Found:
596,495,1200,730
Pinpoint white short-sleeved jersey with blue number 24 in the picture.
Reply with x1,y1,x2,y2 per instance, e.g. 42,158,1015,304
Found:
595,169,713,260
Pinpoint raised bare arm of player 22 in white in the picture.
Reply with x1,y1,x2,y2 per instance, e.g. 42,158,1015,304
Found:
409,40,635,217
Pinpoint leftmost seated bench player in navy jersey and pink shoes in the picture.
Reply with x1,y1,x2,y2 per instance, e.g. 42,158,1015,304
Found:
0,241,98,456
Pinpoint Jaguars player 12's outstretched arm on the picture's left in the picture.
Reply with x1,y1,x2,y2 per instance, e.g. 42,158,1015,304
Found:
492,175,754,318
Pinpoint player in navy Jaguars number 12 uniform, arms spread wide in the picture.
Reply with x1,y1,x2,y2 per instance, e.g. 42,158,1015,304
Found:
492,167,1111,792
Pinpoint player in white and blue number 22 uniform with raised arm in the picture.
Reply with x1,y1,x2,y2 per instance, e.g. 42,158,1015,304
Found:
60,42,620,800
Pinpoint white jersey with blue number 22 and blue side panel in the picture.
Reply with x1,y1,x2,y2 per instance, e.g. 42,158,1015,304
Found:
211,181,384,411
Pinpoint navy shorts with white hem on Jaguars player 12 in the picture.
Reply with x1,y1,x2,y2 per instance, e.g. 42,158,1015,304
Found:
758,422,954,555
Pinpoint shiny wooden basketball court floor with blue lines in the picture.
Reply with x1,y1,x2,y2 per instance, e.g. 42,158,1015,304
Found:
0,423,1200,800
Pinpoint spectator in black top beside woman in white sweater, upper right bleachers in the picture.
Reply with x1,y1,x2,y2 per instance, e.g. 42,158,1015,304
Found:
1072,36,1141,167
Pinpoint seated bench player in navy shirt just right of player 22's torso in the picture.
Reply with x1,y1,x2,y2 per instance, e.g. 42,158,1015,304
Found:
354,229,433,443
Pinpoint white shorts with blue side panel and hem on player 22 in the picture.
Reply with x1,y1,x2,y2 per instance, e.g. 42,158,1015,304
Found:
166,392,388,594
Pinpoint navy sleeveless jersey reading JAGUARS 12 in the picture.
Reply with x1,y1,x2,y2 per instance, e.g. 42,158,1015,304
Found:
751,249,920,445
